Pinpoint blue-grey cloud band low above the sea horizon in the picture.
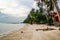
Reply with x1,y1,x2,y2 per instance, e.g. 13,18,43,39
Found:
0,12,26,23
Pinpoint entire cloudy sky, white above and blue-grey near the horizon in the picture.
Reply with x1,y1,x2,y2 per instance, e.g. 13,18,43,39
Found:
0,0,60,22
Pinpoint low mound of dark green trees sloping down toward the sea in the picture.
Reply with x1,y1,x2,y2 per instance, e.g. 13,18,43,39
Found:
24,9,47,23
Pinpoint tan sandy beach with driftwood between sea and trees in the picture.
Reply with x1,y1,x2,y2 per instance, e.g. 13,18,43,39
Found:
0,24,60,40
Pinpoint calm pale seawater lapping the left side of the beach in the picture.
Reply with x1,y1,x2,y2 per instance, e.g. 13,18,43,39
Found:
0,23,25,35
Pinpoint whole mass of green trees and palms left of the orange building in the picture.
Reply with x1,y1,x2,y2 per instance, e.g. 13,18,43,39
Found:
24,0,56,23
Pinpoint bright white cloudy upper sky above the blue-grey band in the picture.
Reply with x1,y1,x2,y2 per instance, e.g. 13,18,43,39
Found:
0,0,36,17
